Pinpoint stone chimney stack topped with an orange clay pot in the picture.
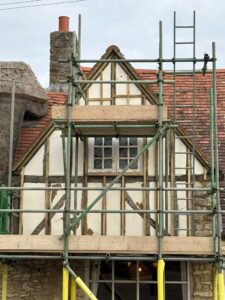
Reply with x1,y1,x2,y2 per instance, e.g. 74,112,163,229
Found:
49,16,77,91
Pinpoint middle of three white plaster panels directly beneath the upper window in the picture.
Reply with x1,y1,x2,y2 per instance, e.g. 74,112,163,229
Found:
106,184,120,236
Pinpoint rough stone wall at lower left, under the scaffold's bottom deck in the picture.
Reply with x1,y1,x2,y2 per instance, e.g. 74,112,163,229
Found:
0,260,84,300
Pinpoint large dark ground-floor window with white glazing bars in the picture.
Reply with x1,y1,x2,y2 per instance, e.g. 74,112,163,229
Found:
89,261,190,300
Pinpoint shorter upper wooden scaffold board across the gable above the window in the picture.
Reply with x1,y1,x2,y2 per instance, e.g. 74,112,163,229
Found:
52,105,168,124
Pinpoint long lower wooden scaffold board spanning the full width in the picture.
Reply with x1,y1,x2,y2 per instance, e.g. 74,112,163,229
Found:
0,235,220,255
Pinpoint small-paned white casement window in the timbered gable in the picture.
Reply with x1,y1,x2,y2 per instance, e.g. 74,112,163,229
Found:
89,137,142,172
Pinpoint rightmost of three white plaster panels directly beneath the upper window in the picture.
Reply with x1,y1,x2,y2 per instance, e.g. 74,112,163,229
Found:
125,182,143,236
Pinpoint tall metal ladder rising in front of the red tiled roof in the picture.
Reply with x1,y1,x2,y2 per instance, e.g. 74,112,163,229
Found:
173,11,196,235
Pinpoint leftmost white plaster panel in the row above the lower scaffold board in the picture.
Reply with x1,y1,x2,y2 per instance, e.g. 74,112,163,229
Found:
22,183,45,234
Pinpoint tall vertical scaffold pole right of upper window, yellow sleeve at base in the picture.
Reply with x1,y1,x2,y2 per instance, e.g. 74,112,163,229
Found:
157,21,165,300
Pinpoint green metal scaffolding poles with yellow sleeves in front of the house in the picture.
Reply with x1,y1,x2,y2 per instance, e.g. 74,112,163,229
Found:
0,12,225,300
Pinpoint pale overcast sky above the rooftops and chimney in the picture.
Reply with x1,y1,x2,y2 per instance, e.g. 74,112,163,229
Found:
0,0,225,87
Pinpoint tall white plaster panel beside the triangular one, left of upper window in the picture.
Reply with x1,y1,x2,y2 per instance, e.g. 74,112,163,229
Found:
49,130,64,176
